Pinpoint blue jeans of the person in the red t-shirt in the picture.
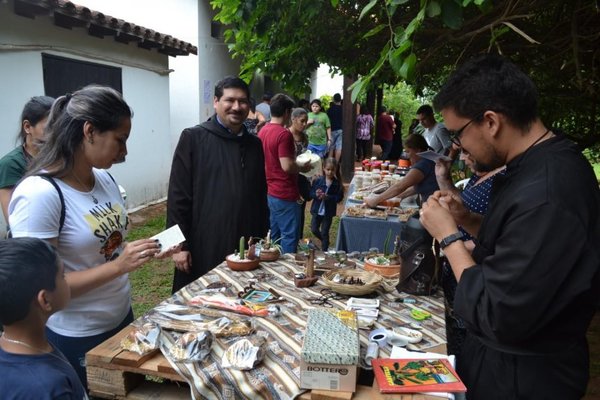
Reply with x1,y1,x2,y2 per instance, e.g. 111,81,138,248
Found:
267,196,301,253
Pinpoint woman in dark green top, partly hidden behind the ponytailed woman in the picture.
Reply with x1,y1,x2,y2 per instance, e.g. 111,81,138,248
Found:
0,96,54,221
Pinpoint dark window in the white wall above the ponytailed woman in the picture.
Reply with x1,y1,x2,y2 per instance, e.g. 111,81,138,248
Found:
42,54,123,97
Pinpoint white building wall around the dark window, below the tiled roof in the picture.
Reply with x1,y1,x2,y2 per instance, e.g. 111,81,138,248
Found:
0,3,172,232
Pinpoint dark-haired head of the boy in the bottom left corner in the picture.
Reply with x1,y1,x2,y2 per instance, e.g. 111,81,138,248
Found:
0,238,70,325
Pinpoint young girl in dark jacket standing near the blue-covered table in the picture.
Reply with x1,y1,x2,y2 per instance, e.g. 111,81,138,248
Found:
310,158,344,251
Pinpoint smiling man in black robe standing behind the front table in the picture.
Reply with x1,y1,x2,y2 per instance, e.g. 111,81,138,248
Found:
167,76,269,292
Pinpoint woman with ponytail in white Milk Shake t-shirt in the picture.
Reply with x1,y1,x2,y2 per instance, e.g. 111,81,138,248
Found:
9,86,171,387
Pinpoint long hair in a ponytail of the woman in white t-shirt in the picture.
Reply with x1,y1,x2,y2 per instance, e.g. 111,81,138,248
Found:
27,85,133,178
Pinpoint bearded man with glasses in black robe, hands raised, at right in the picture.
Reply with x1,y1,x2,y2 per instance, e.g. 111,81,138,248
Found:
421,56,600,400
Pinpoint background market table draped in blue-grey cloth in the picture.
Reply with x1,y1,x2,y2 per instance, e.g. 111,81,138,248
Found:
335,183,418,252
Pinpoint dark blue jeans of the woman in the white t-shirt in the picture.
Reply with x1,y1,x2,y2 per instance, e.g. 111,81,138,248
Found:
46,309,133,390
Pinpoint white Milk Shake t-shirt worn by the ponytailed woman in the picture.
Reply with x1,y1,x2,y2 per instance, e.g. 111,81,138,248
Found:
9,169,131,337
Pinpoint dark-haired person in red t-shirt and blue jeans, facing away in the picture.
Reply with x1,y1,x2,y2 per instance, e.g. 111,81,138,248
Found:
258,93,310,253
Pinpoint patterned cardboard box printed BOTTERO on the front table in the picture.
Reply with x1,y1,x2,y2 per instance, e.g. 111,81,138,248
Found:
300,309,360,392
